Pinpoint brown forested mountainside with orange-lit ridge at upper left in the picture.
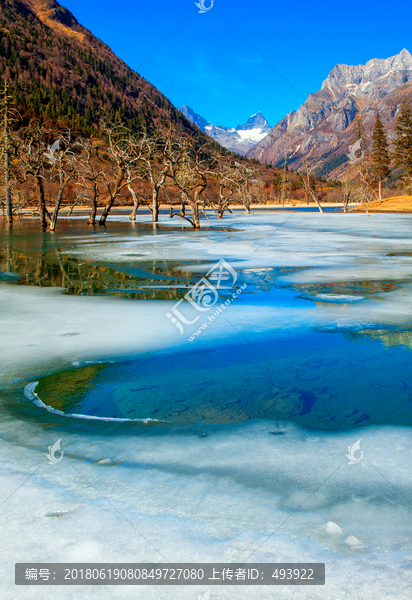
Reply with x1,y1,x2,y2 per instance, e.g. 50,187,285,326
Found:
0,0,217,146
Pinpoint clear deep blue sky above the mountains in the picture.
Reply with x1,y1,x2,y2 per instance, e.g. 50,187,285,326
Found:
62,0,412,127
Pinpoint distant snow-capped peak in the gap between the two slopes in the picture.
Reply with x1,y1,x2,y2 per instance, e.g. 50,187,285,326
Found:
179,106,271,154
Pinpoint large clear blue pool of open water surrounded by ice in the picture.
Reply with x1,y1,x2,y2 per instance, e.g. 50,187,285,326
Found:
36,330,412,430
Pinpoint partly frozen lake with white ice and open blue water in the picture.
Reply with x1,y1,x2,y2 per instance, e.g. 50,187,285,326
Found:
0,212,412,600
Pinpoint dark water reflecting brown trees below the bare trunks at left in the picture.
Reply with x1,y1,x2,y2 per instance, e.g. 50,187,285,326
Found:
0,221,206,300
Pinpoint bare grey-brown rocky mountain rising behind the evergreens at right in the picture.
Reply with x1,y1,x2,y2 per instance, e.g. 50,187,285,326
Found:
247,49,412,177
